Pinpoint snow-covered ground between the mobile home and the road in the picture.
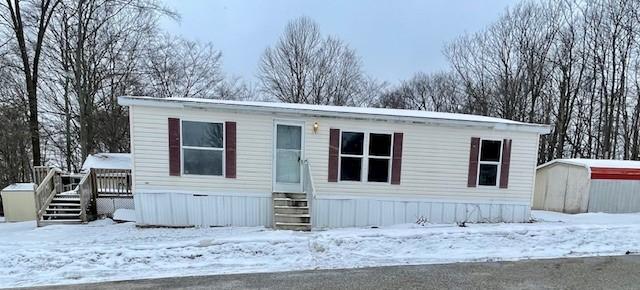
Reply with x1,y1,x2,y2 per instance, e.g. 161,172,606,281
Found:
0,211,640,287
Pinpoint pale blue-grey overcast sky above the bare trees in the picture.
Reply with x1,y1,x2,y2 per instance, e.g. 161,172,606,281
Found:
163,0,518,83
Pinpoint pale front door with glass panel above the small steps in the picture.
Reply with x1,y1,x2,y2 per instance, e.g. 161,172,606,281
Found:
273,121,304,192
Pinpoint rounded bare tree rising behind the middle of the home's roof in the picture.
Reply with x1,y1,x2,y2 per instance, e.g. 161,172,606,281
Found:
258,17,364,105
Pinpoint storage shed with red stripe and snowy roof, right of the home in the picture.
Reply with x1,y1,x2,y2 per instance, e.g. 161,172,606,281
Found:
533,159,640,213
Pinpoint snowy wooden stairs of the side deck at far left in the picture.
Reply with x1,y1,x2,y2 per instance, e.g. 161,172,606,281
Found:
40,191,82,225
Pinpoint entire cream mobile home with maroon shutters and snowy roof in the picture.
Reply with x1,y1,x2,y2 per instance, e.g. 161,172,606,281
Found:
119,97,549,228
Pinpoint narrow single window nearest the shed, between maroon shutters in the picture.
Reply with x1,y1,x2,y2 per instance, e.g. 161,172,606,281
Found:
478,140,502,186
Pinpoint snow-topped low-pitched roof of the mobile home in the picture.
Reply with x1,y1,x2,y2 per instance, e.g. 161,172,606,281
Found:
118,96,550,134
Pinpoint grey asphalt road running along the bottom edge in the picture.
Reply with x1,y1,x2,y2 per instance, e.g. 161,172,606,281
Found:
17,256,640,289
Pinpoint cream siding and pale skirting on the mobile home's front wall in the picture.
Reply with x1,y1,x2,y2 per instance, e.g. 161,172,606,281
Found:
130,105,538,227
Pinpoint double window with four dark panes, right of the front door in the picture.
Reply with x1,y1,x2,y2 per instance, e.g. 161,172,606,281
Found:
340,132,391,182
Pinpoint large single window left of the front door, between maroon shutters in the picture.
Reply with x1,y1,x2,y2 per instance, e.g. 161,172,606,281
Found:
182,121,224,176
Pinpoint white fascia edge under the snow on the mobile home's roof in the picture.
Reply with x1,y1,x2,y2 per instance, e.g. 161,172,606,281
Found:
118,96,551,135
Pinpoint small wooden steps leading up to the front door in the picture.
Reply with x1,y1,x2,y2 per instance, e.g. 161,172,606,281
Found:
273,192,311,231
